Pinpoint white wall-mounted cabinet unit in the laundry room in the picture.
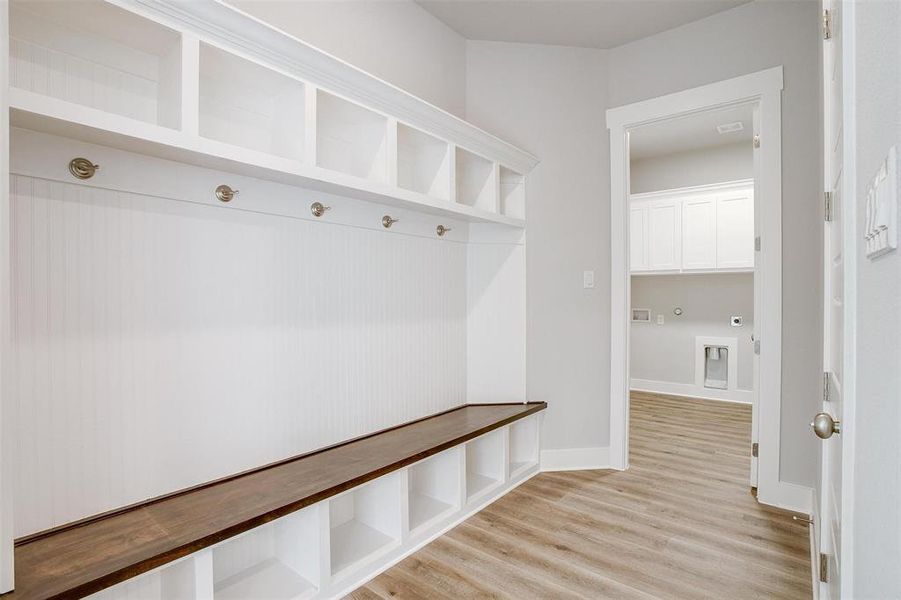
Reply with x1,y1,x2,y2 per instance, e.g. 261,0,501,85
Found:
629,181,754,274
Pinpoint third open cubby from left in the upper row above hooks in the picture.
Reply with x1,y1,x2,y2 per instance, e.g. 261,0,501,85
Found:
316,90,388,182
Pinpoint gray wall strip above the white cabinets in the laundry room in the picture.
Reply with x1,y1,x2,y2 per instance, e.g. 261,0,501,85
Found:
629,143,754,194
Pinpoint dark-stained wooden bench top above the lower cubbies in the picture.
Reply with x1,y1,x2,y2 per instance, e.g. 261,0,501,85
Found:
2,402,547,600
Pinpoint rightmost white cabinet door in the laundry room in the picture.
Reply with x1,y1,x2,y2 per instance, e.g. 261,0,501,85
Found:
716,188,754,269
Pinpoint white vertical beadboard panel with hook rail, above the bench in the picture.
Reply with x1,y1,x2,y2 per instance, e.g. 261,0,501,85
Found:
9,132,478,536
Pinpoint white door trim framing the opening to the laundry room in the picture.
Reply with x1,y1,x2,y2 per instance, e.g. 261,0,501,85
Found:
607,66,788,508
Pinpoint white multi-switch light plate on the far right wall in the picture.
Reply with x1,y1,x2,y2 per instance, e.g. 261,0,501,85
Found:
864,146,898,260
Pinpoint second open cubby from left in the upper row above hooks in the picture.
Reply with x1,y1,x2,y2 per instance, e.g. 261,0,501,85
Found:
200,44,305,161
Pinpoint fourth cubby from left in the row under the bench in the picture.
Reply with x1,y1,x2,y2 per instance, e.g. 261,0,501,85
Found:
409,448,462,533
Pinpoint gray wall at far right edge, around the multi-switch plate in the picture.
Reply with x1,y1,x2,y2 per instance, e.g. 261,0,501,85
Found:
845,2,901,599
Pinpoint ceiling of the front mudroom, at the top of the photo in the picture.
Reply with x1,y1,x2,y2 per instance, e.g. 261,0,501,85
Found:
416,0,750,48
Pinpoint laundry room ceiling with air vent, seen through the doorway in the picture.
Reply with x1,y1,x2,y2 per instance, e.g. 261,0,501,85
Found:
629,105,754,159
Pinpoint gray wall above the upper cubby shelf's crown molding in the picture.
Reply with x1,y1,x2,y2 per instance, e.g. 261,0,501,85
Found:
226,0,466,117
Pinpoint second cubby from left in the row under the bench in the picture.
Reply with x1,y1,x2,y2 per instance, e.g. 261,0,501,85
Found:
212,504,322,600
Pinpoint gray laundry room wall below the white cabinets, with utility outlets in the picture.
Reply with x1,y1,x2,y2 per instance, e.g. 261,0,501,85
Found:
630,273,754,390
